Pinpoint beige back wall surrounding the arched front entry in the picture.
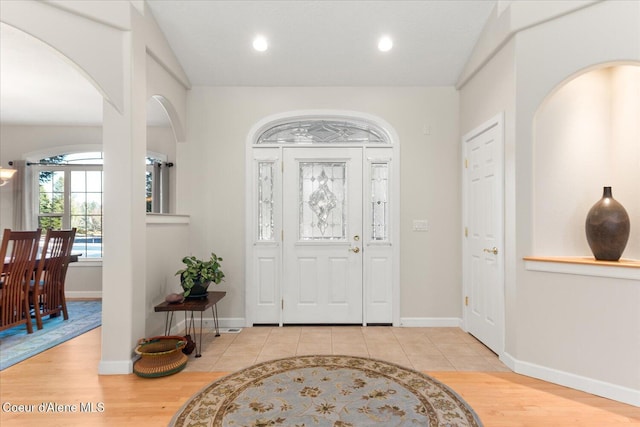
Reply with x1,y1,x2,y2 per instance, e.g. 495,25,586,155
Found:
182,87,462,319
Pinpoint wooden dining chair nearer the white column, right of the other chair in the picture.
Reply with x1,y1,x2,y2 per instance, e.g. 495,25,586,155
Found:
30,228,76,329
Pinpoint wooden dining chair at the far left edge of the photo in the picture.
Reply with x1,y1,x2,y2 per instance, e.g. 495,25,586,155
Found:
0,229,41,334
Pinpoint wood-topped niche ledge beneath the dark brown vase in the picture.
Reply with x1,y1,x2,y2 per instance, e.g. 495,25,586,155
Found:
523,256,640,280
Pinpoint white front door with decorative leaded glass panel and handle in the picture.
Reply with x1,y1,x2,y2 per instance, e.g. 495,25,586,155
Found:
282,147,363,324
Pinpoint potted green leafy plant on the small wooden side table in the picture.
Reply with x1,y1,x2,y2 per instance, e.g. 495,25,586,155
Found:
176,253,224,298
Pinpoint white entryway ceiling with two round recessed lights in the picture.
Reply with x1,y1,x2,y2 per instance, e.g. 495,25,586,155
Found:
148,0,496,86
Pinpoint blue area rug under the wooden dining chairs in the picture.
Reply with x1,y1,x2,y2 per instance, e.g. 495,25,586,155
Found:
0,301,102,371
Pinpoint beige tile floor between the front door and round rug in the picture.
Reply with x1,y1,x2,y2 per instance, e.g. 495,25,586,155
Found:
185,326,509,372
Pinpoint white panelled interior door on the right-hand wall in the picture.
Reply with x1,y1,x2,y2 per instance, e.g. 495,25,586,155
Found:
463,118,504,354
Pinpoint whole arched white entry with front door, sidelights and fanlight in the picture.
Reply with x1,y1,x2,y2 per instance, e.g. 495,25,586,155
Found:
246,112,399,325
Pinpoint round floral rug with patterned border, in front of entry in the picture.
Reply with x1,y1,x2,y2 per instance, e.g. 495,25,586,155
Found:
170,356,482,427
